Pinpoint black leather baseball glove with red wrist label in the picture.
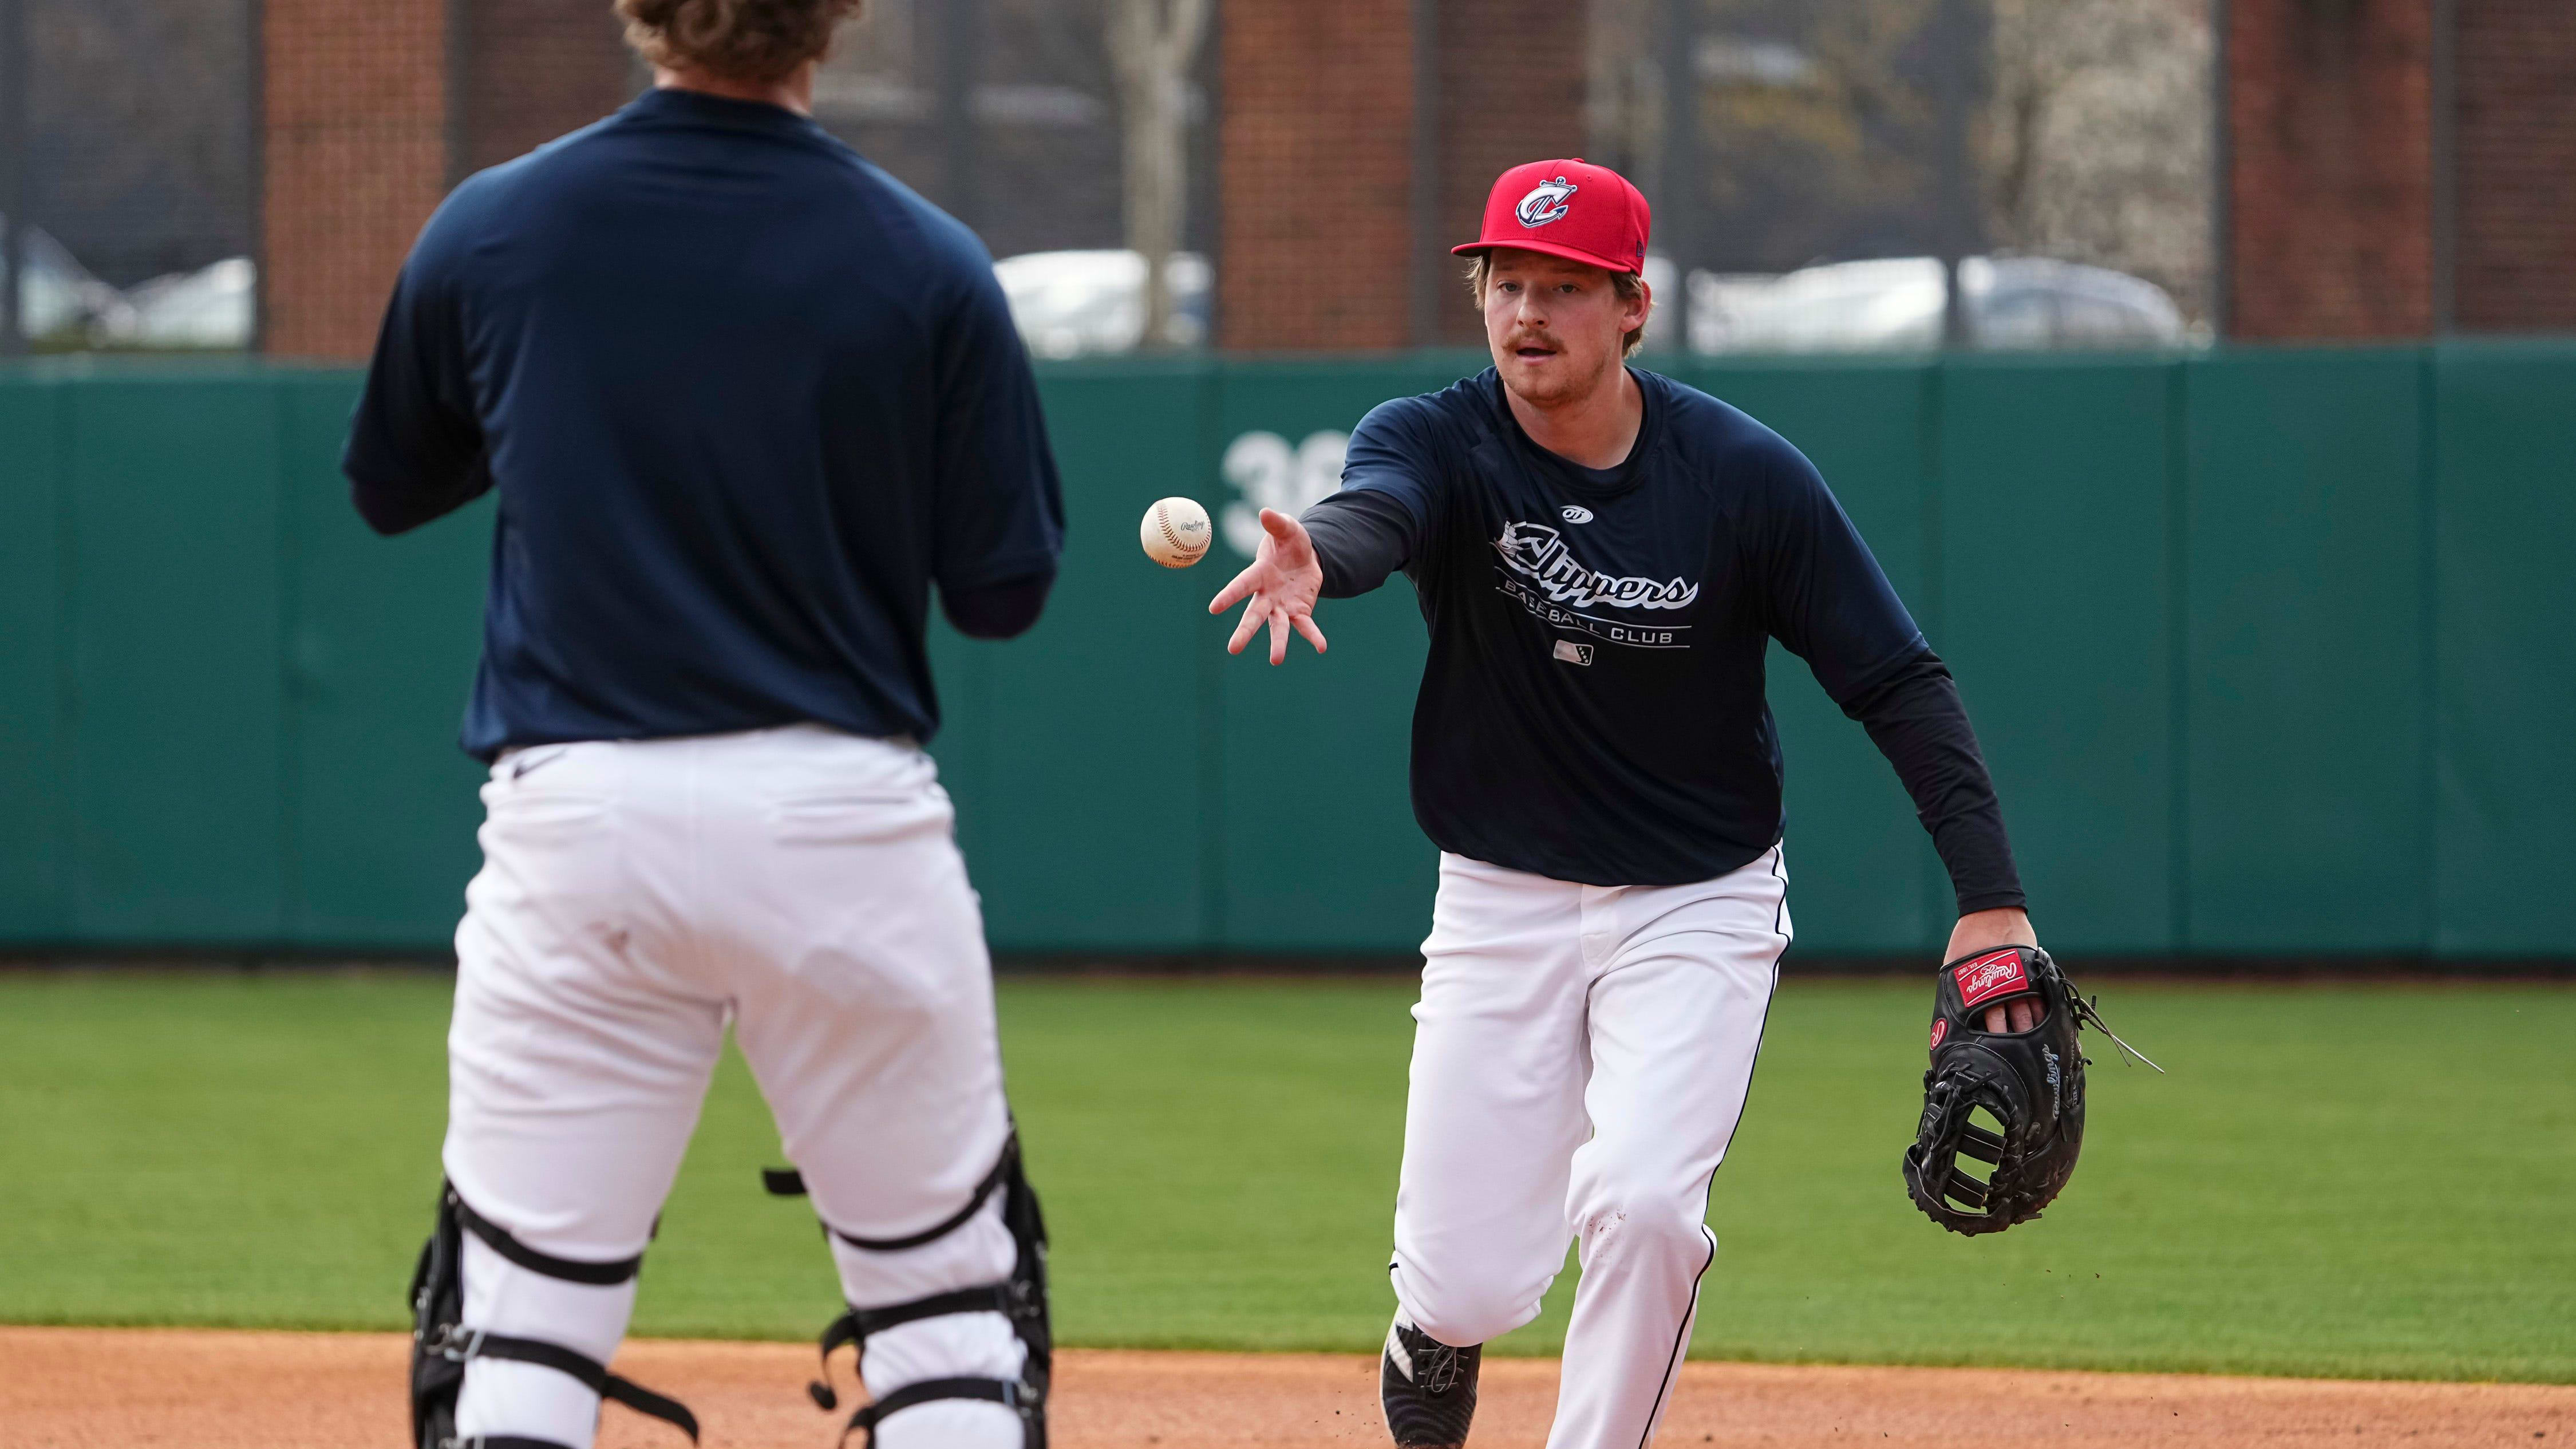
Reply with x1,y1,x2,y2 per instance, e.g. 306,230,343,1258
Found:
1904,946,2164,1235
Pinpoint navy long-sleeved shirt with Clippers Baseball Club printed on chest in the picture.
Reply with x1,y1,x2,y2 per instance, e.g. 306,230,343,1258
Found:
1306,369,2022,910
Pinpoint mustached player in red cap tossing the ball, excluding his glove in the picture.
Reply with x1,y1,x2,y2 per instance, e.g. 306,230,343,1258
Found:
1211,160,2038,1449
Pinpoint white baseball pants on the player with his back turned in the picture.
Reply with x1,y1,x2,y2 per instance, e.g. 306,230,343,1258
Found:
443,727,1023,1449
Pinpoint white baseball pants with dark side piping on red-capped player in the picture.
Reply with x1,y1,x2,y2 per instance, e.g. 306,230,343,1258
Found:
1391,846,1791,1449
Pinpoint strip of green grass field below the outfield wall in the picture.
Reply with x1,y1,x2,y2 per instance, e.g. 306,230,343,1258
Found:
0,972,2576,1382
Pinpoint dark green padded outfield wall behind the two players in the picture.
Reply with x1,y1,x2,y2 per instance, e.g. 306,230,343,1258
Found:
0,343,2576,959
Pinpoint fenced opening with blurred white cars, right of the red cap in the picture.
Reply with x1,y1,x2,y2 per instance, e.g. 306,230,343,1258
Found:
1587,0,2218,353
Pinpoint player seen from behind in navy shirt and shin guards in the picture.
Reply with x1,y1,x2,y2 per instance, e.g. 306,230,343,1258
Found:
345,0,1061,1449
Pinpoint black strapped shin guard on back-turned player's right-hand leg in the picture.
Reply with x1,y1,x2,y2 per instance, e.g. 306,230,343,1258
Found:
760,1130,1056,1449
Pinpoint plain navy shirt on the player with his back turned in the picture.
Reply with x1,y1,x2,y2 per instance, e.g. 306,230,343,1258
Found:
345,90,1064,758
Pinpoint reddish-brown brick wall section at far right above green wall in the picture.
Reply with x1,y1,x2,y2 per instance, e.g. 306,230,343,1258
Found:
2223,0,2576,340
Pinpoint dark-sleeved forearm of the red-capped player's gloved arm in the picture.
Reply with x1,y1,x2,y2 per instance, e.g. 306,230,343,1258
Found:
1844,652,2028,915
